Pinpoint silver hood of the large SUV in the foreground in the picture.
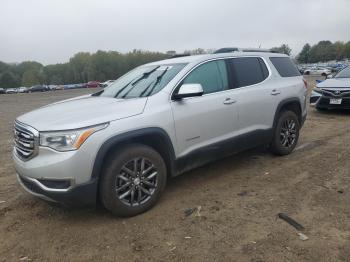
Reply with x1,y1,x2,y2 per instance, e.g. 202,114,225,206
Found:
17,95,147,131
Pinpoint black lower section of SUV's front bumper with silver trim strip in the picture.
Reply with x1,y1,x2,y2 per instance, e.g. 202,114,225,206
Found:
17,174,98,207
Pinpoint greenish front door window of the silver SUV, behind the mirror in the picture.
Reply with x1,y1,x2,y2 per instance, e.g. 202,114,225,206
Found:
183,60,229,94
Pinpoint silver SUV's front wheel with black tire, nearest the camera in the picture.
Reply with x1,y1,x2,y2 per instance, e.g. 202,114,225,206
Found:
100,144,167,217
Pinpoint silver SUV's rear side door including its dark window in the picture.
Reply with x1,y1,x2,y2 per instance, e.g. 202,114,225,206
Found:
231,57,280,134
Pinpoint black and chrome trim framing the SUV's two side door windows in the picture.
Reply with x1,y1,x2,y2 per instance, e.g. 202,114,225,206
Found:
169,55,272,101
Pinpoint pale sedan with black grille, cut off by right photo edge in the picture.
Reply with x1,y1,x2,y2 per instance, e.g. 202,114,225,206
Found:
310,66,350,110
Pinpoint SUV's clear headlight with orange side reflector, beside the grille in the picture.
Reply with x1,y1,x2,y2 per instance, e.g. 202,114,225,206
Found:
40,123,108,151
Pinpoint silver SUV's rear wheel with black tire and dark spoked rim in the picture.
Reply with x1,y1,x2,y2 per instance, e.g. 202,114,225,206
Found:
271,111,300,156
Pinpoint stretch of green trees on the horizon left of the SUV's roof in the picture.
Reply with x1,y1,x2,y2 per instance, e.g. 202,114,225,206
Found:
0,50,169,88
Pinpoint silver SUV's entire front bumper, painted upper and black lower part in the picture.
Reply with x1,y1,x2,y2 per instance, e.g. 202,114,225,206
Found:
12,141,98,206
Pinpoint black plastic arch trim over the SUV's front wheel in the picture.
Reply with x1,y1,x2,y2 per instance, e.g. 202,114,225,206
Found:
92,127,175,179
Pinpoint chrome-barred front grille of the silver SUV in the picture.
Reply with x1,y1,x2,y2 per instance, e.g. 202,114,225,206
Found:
14,122,38,160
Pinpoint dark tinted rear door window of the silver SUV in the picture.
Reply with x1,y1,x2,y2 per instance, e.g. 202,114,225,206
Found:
231,57,269,87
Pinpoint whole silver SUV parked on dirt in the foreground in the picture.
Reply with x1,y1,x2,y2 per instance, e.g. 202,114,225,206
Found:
13,51,307,216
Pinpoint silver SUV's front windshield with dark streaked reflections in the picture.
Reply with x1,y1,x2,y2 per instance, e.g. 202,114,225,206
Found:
97,64,186,99
